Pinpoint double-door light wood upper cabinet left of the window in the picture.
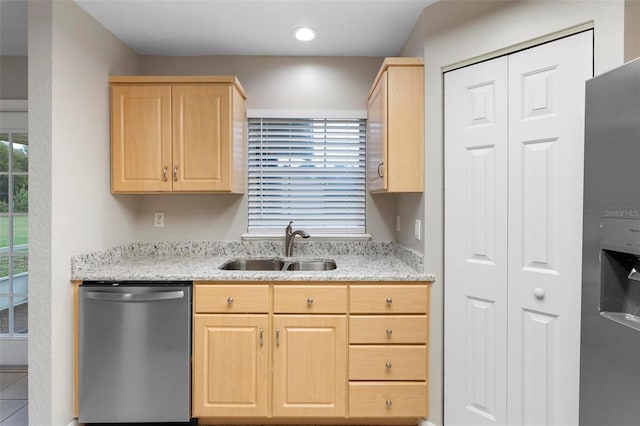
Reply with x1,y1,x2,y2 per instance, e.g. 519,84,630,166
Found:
109,76,246,194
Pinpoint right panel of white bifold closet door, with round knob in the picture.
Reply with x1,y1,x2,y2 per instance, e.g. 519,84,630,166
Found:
507,31,593,426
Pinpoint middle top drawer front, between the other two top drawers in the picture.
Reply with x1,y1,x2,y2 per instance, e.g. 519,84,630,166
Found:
273,285,347,314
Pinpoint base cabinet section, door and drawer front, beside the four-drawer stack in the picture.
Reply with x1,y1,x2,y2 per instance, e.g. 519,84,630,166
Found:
273,284,347,417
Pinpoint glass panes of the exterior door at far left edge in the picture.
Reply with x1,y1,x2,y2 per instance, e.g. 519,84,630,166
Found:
0,131,29,336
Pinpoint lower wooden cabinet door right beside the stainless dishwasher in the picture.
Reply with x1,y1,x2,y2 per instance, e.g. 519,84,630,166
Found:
192,314,269,417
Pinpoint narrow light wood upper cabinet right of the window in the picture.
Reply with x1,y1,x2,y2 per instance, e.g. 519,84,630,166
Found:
367,58,424,193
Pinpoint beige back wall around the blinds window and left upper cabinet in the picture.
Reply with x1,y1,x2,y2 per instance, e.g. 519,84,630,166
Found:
136,56,396,241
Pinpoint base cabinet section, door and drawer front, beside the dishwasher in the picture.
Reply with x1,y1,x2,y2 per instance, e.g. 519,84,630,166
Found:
192,285,270,417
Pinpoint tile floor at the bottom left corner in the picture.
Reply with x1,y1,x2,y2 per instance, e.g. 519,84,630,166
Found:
0,367,29,426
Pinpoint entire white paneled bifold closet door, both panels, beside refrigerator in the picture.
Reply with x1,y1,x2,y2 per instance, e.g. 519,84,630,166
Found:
445,31,593,425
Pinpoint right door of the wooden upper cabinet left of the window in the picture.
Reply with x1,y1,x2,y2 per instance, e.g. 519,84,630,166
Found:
171,84,232,192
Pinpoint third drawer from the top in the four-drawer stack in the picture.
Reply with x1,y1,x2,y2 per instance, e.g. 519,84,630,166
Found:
349,346,427,380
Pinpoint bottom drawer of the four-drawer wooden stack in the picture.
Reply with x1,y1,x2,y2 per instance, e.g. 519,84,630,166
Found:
349,382,429,417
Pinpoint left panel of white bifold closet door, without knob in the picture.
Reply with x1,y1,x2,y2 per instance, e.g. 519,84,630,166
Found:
444,57,507,425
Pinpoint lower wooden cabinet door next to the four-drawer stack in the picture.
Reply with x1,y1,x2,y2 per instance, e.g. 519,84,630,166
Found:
273,315,347,417
